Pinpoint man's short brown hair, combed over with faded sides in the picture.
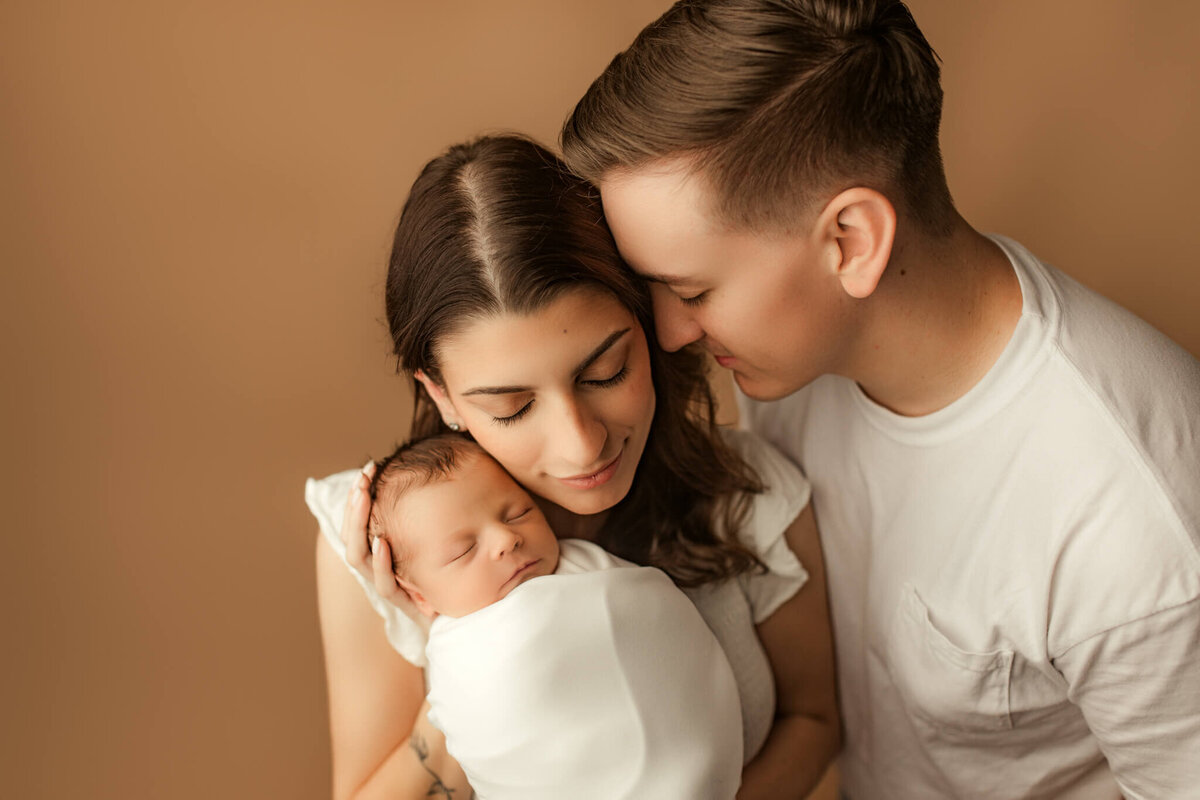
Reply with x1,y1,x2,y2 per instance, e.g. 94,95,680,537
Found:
562,0,955,235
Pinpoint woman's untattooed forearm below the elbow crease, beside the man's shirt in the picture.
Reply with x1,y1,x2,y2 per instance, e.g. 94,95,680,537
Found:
737,715,841,800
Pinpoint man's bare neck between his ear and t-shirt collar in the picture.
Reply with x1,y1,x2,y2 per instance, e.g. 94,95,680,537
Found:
848,219,1021,416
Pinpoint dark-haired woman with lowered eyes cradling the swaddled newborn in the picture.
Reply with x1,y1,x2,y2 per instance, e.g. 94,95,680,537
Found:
308,137,840,800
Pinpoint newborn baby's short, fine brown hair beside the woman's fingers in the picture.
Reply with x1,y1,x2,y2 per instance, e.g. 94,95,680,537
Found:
367,433,491,575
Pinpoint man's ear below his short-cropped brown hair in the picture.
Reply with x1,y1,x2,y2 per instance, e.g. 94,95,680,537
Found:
817,186,896,299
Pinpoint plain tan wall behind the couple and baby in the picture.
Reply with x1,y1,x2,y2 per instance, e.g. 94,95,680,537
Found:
0,0,1200,799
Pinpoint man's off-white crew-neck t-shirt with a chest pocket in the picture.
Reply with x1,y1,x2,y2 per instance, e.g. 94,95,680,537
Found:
740,237,1200,800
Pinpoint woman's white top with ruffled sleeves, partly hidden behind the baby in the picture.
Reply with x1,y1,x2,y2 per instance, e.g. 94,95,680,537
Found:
305,431,810,762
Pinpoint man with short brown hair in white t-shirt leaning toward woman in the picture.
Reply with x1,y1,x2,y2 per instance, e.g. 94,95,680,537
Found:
563,0,1200,800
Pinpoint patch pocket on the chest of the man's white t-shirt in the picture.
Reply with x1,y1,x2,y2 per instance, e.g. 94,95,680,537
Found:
887,584,1013,740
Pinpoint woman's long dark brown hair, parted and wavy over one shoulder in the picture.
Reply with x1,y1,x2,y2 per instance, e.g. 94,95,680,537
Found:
386,136,762,587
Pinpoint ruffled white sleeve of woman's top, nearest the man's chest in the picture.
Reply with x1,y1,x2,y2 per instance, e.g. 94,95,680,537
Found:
724,429,812,625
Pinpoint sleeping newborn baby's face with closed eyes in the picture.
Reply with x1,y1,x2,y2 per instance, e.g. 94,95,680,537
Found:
388,456,558,616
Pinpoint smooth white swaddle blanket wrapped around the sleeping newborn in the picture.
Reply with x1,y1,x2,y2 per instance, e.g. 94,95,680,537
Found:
426,540,742,800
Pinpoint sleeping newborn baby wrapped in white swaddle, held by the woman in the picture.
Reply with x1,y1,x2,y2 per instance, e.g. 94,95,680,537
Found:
370,434,742,800
